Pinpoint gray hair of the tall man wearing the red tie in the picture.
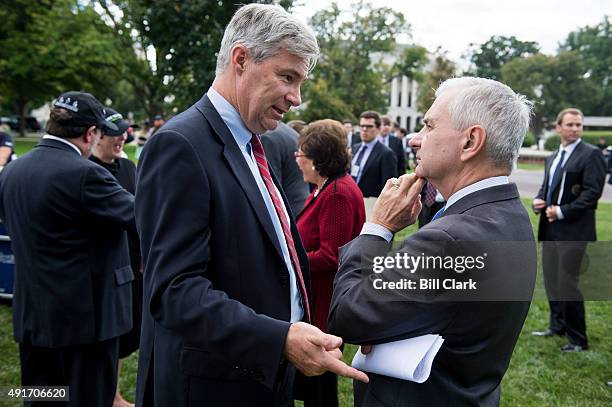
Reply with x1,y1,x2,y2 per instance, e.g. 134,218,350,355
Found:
215,4,319,75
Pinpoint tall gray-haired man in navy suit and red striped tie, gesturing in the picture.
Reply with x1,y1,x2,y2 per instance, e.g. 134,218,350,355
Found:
136,4,367,406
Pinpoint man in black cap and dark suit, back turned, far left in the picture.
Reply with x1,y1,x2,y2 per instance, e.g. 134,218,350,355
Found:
0,92,136,407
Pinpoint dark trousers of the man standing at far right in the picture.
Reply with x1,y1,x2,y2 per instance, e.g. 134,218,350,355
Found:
542,241,588,346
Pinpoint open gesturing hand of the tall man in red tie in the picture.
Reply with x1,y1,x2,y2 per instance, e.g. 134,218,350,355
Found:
285,322,368,383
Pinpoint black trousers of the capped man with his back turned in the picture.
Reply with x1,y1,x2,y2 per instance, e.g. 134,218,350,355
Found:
19,338,119,407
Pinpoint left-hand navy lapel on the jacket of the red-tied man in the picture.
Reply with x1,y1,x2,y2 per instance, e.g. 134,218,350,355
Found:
196,95,287,257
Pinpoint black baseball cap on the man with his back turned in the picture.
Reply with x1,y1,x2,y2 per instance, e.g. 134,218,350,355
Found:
53,91,119,132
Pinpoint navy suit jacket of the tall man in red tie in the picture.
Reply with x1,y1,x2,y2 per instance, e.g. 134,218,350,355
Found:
136,96,309,406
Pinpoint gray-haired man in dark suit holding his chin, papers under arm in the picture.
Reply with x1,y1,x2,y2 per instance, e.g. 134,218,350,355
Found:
329,77,536,406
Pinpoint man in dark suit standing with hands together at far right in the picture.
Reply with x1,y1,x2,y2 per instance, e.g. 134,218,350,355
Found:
533,108,606,352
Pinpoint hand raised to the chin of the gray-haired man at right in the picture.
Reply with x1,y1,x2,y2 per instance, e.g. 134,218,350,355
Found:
372,174,426,233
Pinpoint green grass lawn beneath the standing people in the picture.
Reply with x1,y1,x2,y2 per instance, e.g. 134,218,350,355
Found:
0,142,612,407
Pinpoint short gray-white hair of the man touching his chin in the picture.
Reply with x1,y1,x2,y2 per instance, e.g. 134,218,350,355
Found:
436,77,533,170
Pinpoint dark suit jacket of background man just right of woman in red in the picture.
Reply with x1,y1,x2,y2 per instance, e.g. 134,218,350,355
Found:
352,142,397,198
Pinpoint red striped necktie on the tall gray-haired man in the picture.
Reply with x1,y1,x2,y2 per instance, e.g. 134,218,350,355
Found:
251,134,310,322
